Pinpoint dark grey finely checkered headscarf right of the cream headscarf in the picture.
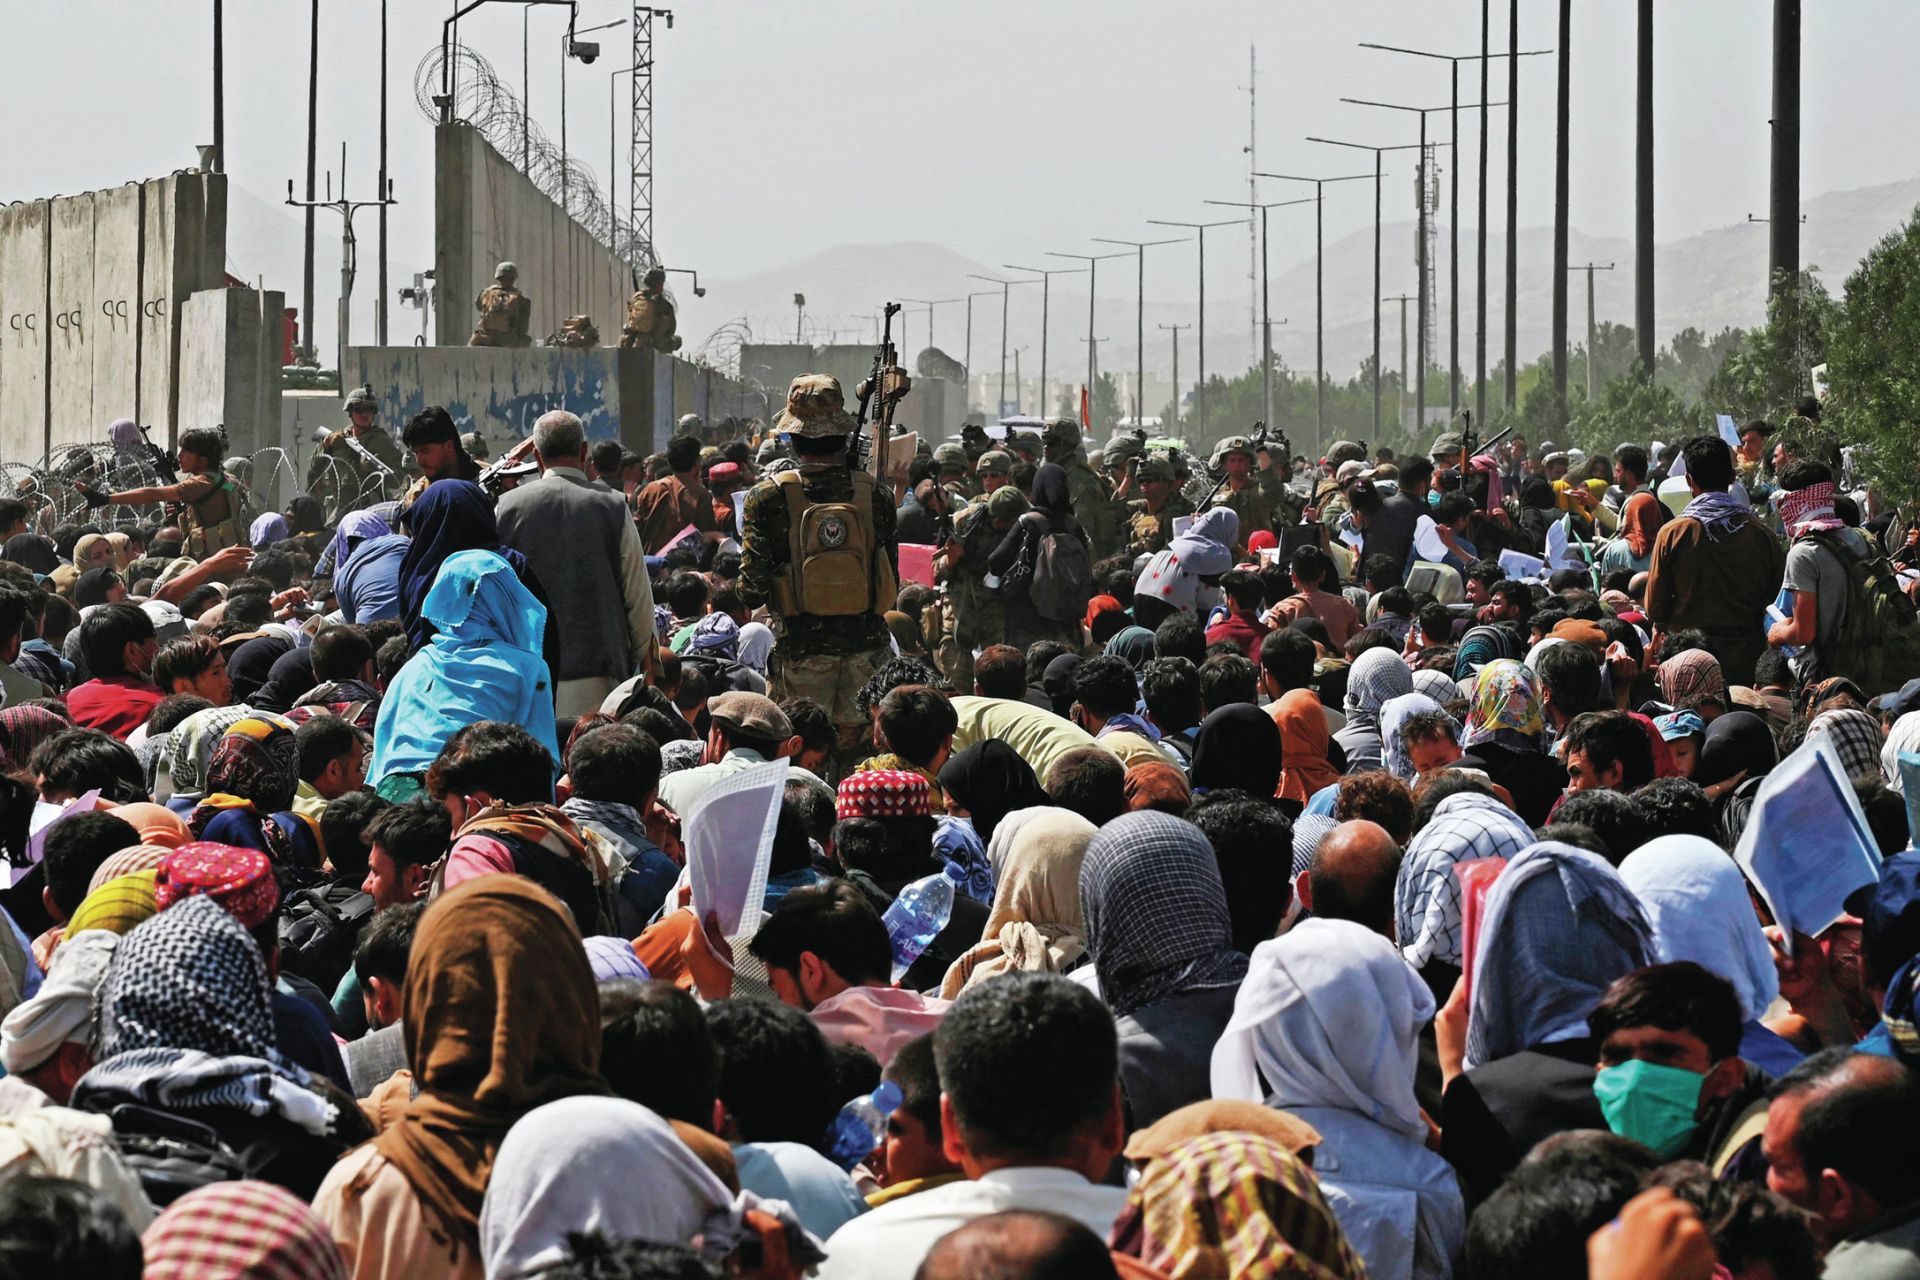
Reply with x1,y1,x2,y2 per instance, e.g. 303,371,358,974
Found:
1079,812,1246,1017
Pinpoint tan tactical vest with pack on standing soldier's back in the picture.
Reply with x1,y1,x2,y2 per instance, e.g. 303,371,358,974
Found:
774,470,899,618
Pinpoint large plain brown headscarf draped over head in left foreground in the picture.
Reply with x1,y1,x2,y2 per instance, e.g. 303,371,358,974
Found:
374,875,611,1249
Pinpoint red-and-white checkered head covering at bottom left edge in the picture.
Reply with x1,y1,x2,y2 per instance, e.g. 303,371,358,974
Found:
140,1182,348,1280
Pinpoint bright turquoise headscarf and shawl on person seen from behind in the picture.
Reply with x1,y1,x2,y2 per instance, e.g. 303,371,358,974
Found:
367,552,561,783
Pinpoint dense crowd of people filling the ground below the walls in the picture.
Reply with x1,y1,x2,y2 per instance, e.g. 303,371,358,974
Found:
0,391,1920,1280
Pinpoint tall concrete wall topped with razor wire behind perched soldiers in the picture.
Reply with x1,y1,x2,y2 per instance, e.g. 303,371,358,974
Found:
434,123,636,347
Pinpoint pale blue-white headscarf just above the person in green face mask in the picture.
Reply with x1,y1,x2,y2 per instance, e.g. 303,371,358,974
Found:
1620,835,1780,1021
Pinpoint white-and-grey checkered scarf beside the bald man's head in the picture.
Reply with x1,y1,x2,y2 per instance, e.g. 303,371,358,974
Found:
1394,791,1534,969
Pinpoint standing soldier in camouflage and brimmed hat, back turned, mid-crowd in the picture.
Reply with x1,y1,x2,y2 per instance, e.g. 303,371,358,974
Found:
739,374,900,777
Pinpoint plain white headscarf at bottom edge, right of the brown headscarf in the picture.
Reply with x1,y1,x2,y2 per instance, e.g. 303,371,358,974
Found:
480,1098,810,1280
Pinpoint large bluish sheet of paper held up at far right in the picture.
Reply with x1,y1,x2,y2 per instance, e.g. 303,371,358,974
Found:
1734,735,1880,954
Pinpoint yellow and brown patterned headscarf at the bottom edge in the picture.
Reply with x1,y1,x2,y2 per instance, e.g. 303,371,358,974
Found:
1112,1132,1367,1280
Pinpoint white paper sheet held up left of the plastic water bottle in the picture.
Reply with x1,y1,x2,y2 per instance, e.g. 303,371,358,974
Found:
682,760,787,938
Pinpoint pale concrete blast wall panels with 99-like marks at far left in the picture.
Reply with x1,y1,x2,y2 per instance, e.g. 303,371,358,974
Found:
0,171,228,462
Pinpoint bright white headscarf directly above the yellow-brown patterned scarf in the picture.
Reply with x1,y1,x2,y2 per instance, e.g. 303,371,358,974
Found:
1212,917,1434,1140
